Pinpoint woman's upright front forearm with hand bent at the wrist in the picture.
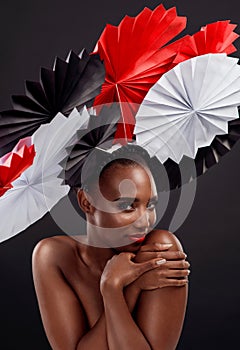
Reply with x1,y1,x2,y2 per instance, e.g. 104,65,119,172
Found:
100,253,168,350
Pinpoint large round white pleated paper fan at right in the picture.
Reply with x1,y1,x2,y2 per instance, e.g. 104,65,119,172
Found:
135,54,240,163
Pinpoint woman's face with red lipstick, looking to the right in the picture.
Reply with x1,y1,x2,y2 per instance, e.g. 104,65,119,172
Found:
87,164,157,251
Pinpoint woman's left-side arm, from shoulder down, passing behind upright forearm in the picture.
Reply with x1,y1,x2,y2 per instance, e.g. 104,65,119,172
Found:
33,238,163,350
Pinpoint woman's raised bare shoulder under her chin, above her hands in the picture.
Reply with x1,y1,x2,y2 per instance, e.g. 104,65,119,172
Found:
144,230,183,251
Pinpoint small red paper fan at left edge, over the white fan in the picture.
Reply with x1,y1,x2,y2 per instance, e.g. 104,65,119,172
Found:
0,137,35,196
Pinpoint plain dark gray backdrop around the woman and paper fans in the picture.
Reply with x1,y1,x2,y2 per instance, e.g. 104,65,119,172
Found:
0,0,240,350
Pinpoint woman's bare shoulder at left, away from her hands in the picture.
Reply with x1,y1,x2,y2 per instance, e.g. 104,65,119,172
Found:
32,236,77,267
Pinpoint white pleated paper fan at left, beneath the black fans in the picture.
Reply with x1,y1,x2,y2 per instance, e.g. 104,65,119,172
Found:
0,109,89,241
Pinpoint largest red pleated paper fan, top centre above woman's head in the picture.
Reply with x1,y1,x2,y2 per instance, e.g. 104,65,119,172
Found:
94,5,186,140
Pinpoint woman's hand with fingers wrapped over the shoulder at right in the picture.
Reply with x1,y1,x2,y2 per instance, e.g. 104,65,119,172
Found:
134,243,190,290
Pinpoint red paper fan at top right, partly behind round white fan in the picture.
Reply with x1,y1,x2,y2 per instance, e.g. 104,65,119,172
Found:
173,21,239,66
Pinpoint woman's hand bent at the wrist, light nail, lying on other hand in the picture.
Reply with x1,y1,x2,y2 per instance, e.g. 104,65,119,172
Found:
100,252,166,292
